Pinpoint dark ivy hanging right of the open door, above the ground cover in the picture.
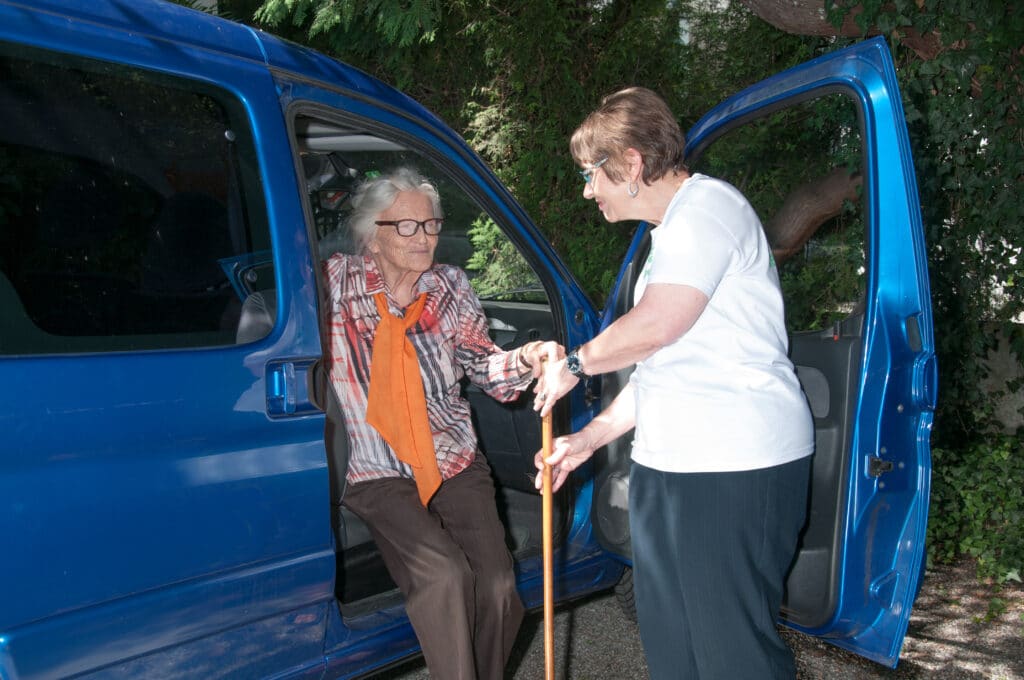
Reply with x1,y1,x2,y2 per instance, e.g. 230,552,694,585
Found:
831,0,1024,447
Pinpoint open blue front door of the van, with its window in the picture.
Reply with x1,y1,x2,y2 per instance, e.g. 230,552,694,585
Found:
592,34,937,667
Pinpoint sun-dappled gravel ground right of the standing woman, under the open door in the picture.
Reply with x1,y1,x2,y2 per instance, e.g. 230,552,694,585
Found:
783,561,1024,680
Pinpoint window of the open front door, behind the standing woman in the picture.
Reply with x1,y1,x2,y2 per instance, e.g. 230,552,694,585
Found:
694,94,866,333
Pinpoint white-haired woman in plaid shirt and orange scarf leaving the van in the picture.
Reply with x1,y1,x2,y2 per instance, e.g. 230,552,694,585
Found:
325,168,564,679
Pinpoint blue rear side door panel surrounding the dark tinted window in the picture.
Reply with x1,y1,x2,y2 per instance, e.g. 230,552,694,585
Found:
0,3,334,678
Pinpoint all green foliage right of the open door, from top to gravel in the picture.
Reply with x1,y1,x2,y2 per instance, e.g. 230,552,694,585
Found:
833,0,1024,581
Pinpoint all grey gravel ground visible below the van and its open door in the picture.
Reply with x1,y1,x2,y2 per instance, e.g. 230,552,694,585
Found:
378,562,1024,680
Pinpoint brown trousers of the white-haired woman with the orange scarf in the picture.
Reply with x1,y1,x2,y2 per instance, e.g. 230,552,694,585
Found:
344,455,523,680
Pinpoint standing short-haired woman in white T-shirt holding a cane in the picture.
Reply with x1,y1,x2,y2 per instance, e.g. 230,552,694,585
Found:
535,88,814,680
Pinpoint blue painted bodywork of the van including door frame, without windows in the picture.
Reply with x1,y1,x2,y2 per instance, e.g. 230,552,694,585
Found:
0,0,935,680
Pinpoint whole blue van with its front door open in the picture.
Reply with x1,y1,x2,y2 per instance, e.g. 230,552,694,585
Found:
0,0,936,680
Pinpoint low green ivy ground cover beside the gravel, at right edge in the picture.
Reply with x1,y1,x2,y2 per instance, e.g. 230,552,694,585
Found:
928,436,1024,583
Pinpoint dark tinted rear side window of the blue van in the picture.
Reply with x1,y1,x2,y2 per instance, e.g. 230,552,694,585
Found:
0,46,273,355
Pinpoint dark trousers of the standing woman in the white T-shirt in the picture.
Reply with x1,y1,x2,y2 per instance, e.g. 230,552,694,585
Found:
630,457,811,680
